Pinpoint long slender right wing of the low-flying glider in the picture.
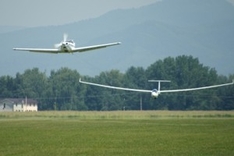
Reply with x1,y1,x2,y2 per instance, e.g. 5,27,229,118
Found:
160,80,234,93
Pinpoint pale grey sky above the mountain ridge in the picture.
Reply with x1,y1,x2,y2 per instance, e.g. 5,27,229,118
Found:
0,0,160,27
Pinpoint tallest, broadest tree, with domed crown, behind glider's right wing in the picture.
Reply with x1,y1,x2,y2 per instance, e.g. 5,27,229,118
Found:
146,55,219,110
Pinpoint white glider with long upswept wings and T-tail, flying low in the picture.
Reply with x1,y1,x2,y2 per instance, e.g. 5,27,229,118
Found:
79,78,234,99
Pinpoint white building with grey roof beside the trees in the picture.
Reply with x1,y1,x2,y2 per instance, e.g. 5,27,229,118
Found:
0,98,38,112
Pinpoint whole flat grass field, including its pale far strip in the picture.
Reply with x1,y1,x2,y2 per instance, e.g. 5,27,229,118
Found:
0,111,234,156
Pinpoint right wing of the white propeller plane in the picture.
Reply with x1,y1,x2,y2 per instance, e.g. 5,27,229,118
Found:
72,42,121,52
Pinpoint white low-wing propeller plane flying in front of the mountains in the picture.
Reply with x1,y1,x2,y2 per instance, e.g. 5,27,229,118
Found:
13,34,121,54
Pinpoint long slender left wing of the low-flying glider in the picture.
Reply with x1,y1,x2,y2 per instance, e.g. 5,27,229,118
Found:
79,78,152,93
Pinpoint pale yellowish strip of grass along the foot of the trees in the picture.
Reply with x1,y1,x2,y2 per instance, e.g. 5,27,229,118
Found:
0,111,234,119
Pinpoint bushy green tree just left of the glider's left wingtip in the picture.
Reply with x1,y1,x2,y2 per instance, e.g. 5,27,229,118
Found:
47,68,87,110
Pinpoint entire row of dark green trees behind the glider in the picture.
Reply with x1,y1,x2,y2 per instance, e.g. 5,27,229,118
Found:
0,55,234,111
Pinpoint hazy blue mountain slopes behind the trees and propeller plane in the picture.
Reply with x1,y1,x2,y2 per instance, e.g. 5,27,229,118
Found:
0,0,234,76
